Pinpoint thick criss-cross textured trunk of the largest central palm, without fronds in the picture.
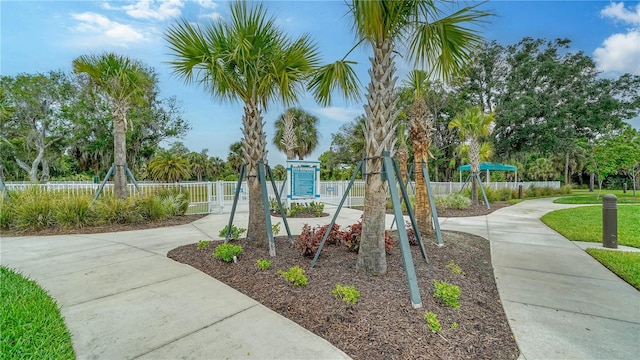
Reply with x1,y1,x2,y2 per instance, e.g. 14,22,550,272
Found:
357,39,397,275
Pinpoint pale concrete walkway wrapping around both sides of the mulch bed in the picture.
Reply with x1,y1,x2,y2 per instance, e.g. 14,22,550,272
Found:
0,199,640,360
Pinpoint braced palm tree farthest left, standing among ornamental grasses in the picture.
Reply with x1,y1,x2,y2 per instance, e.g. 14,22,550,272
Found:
73,53,155,199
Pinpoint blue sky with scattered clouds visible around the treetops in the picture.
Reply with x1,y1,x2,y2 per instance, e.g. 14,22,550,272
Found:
0,0,640,166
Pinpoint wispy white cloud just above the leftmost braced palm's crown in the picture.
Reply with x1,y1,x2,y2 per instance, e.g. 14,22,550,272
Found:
71,12,145,47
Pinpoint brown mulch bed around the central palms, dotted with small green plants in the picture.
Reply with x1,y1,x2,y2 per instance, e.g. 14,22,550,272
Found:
168,231,519,359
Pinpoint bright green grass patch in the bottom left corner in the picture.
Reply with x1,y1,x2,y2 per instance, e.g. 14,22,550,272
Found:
0,266,75,359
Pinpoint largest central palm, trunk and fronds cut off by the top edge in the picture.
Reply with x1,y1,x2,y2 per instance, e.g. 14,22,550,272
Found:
349,0,490,274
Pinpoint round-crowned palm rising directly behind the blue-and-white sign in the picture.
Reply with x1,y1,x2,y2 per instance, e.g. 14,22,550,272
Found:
273,108,320,160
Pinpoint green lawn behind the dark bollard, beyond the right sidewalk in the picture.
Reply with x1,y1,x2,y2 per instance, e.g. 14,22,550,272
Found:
541,205,640,248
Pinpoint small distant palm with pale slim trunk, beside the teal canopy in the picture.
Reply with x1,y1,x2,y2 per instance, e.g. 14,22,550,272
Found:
449,106,495,205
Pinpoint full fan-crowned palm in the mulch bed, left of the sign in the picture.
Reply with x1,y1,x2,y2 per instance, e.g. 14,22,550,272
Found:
166,1,355,246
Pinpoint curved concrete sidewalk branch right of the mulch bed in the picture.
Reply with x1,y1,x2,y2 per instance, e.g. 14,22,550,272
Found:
441,199,640,360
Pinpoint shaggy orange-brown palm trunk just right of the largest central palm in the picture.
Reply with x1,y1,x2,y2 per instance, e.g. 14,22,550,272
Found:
404,70,434,235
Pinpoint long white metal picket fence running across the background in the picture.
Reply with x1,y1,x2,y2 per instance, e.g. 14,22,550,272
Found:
6,180,560,214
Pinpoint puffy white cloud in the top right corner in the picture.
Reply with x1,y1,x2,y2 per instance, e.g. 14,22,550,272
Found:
593,2,640,75
